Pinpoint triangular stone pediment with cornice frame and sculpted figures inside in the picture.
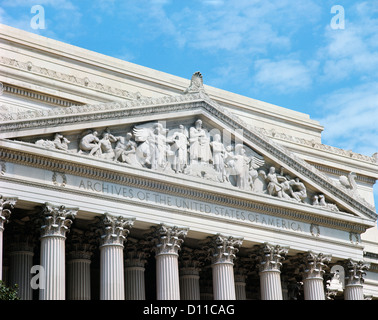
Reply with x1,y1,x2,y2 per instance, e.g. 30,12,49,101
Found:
0,90,376,225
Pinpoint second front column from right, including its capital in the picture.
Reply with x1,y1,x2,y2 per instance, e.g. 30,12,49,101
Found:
303,251,331,300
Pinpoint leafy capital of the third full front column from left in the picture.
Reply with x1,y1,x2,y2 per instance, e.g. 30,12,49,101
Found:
153,224,189,254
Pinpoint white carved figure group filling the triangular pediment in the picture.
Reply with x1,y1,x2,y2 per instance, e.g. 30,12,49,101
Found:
26,119,338,211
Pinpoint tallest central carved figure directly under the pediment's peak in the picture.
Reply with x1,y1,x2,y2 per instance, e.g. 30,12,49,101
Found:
189,119,211,163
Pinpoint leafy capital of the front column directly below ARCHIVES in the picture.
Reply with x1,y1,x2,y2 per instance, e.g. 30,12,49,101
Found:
98,212,135,246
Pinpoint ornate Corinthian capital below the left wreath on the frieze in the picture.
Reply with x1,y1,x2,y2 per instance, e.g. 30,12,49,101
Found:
41,202,78,237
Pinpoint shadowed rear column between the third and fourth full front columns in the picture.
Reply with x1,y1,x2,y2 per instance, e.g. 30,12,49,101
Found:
179,247,201,300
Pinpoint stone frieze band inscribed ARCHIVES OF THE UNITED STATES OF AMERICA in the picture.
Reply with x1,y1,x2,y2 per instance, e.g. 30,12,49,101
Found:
3,162,360,245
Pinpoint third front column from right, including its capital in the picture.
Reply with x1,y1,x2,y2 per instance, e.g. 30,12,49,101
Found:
259,243,289,300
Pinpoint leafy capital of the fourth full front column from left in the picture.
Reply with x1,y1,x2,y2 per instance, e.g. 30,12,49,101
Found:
209,234,243,264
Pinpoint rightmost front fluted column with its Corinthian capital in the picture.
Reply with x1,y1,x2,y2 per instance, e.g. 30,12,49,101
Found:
344,259,370,300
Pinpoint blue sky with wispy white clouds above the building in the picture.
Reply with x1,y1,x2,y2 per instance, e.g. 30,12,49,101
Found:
0,0,378,209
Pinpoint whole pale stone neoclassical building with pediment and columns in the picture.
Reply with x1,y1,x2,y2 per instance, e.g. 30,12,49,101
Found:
0,25,378,300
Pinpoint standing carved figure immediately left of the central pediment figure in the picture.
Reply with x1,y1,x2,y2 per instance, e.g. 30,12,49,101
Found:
171,125,189,173
